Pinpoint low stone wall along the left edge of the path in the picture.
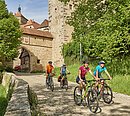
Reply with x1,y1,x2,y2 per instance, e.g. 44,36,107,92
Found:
2,73,37,116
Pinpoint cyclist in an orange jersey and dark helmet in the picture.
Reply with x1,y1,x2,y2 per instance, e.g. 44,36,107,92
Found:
46,61,54,83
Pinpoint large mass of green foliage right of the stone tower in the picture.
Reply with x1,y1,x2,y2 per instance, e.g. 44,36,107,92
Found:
62,0,130,75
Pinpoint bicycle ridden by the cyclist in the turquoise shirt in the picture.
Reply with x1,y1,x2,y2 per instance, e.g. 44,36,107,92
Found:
95,79,113,104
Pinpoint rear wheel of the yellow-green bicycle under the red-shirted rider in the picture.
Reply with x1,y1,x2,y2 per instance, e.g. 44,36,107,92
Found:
74,86,82,105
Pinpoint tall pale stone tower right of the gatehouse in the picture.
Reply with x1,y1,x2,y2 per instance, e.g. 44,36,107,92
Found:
48,0,74,66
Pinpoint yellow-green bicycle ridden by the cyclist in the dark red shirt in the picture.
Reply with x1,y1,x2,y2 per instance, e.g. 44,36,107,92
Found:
74,80,99,113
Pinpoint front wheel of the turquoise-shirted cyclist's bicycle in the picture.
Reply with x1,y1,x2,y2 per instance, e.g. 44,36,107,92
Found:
102,86,113,104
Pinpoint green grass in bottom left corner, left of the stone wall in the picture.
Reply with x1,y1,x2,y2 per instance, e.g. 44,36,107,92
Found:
0,85,8,116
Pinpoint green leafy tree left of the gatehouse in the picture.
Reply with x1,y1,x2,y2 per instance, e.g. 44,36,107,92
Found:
0,0,21,64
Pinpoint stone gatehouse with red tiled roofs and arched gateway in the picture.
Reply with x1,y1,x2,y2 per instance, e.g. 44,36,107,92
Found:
13,8,53,72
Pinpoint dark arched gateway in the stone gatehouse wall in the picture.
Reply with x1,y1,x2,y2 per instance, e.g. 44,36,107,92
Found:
19,48,30,71
